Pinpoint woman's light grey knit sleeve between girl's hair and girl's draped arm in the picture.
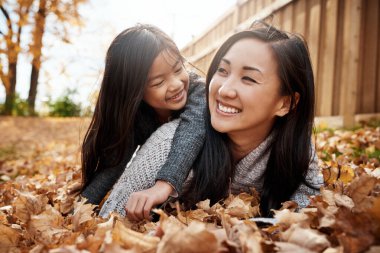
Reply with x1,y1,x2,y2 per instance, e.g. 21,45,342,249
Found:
99,119,180,218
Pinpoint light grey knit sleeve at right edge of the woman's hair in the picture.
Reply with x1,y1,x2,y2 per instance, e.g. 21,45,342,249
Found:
290,145,323,208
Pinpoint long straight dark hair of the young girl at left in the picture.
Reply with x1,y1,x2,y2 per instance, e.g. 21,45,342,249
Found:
82,24,183,189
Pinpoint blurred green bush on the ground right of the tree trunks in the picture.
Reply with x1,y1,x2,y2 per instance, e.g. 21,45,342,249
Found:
48,89,81,117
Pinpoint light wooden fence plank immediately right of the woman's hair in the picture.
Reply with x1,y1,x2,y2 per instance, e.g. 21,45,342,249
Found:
318,0,338,116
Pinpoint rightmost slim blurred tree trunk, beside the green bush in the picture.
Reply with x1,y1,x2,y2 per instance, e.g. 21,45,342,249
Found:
28,0,47,115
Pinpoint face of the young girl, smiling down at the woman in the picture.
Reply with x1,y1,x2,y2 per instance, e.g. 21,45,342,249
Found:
143,50,189,121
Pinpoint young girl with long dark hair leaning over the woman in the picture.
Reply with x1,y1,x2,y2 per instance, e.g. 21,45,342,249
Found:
81,25,206,213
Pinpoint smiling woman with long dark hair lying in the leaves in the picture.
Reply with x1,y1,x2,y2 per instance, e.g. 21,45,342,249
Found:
102,22,323,220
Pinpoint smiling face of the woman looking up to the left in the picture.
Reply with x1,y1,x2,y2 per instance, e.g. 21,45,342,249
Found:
209,38,286,138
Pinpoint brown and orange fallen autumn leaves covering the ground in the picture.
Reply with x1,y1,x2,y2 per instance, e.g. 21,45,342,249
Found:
0,118,380,253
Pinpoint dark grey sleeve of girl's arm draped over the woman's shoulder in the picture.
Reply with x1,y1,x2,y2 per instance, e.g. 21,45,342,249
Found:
156,74,206,194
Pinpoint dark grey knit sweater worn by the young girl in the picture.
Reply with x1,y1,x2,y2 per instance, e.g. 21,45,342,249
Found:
82,73,206,204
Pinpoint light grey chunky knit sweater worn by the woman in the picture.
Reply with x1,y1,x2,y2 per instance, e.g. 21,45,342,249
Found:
100,120,323,217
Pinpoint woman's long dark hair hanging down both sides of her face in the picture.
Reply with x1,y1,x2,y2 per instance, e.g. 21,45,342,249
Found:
182,21,314,216
